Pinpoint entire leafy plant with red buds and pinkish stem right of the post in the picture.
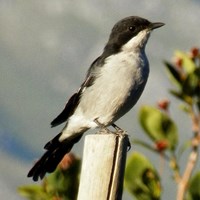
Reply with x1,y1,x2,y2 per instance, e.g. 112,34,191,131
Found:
125,48,200,200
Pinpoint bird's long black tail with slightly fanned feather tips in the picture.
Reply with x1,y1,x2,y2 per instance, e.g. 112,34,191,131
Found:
27,133,82,181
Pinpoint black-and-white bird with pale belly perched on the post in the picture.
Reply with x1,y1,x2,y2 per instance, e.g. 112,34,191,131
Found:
27,16,164,181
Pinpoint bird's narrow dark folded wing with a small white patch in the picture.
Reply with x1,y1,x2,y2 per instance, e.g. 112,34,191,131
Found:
51,57,99,127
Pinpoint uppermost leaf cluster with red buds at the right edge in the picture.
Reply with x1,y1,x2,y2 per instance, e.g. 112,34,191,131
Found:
165,51,200,105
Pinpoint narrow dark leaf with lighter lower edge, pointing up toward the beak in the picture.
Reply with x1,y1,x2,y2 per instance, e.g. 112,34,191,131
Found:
164,61,183,88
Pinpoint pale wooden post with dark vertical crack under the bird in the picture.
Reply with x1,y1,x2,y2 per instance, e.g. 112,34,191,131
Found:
78,132,129,200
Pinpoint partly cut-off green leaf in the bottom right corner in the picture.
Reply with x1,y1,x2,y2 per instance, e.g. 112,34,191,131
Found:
187,171,200,200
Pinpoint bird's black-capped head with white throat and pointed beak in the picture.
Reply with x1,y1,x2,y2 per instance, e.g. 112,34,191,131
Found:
104,16,164,53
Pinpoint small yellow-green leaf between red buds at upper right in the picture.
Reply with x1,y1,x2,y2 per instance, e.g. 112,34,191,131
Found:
175,51,196,74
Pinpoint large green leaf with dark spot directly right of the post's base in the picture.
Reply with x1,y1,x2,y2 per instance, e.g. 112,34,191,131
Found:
125,152,162,200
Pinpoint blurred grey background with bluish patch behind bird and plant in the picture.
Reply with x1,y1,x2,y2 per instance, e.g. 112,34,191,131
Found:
0,0,200,200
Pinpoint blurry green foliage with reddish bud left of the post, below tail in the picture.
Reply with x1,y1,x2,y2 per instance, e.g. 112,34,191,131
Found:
18,154,80,200
